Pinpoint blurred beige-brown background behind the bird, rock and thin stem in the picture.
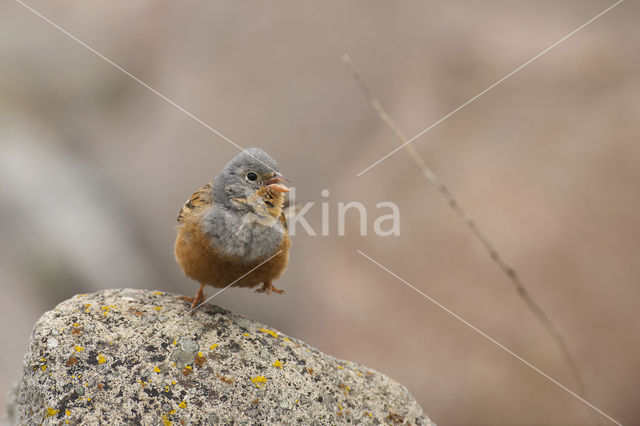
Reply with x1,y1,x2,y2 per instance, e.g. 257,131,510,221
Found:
0,0,640,425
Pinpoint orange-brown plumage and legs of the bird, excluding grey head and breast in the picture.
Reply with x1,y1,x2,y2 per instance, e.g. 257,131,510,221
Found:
174,150,291,314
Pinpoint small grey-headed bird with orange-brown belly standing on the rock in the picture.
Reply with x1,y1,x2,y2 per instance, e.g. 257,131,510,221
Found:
174,148,291,315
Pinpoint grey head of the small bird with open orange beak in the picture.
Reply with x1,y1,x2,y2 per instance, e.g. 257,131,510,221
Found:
213,148,289,218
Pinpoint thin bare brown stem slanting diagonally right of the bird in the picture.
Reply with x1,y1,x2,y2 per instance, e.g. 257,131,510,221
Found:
342,54,587,422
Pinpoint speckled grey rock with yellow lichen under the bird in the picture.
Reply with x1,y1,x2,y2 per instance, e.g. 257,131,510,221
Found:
9,289,433,425
